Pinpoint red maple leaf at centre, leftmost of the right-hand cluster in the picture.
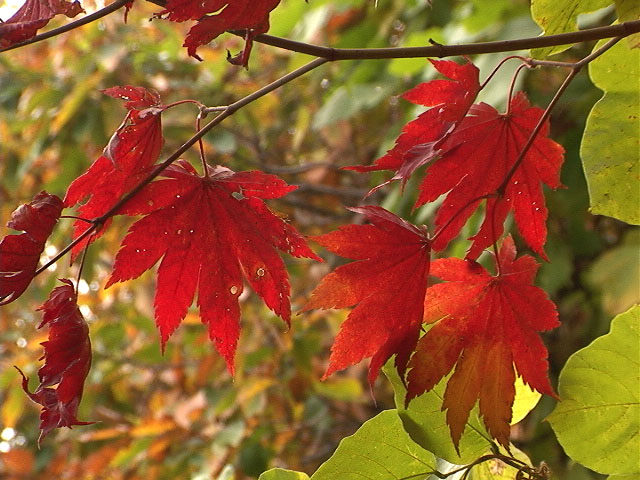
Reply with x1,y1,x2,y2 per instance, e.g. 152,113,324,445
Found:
303,206,430,384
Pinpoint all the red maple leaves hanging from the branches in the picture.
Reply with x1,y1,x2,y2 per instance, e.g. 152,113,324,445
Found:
0,0,584,458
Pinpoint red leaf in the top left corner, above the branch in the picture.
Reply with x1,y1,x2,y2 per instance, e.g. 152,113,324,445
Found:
0,0,84,49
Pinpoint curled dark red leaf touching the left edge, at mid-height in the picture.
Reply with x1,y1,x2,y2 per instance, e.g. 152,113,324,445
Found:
0,192,63,305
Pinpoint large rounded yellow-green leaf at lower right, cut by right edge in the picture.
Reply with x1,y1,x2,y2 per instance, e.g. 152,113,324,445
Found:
548,305,640,475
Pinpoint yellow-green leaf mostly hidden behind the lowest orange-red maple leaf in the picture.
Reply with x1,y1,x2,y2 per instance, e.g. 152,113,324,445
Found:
383,365,540,465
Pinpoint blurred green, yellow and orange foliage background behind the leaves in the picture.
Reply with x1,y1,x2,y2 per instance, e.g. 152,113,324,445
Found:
0,0,640,480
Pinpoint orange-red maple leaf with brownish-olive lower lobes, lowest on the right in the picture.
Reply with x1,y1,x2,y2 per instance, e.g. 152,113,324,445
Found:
406,236,558,446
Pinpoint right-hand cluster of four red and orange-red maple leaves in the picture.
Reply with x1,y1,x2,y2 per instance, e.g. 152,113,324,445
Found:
305,60,564,446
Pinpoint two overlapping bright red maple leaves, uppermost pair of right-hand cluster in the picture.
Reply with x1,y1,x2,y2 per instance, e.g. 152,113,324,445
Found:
350,61,564,260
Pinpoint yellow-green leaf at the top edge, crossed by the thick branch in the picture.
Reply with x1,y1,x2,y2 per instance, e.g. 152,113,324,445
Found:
531,0,612,58
